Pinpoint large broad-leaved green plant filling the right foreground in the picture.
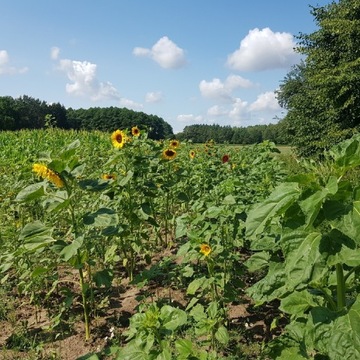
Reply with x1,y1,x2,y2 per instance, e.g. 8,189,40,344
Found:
246,136,360,360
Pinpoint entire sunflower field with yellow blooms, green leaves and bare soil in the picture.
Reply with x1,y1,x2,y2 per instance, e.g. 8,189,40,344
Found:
0,126,360,360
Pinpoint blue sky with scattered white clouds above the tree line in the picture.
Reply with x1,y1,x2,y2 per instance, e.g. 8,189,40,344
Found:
0,0,330,133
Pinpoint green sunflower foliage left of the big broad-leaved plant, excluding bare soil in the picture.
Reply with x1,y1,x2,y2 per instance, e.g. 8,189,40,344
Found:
0,126,285,360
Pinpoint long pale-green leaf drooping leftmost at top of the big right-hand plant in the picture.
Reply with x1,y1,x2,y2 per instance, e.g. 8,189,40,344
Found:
246,182,300,237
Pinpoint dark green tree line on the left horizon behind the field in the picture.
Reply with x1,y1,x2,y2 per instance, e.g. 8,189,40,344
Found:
0,95,174,140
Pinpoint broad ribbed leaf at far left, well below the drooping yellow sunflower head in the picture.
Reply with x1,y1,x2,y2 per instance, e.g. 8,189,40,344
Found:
19,221,55,251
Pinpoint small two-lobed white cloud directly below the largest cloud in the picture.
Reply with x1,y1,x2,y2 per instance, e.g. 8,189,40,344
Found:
199,75,253,101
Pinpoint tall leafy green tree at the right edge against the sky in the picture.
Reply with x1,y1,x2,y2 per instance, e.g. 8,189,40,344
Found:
277,0,360,156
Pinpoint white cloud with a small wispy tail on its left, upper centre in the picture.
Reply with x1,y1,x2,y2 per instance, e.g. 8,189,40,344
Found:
133,36,186,69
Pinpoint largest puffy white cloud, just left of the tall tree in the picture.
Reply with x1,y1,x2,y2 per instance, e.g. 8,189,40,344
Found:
227,28,300,71
